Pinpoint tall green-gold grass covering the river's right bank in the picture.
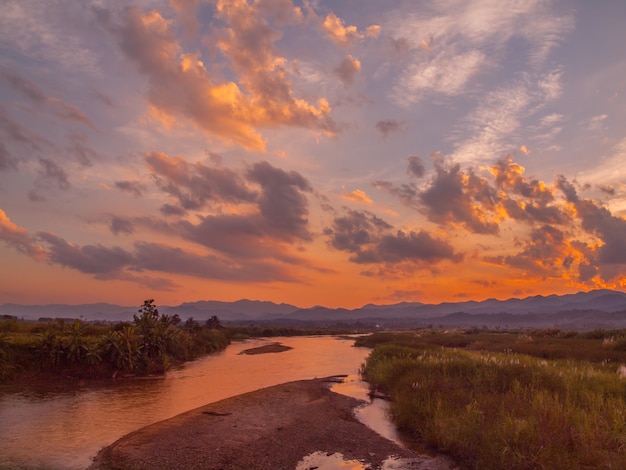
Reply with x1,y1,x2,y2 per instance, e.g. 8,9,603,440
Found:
364,344,626,469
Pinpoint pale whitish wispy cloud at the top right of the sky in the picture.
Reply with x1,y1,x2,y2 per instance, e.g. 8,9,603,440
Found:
388,1,574,105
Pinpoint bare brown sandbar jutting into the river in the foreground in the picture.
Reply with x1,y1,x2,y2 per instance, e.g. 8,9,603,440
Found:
89,379,455,470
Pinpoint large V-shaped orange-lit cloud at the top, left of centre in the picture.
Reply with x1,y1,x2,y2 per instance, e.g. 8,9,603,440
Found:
99,1,338,151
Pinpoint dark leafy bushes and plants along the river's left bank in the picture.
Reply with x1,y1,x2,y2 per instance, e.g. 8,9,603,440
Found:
0,299,230,380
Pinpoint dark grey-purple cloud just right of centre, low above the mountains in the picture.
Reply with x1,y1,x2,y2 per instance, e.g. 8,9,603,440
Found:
324,211,462,265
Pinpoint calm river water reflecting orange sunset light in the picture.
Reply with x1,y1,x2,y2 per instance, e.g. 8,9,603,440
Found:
0,336,393,470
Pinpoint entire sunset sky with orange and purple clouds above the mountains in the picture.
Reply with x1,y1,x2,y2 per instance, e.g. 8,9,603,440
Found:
0,0,626,308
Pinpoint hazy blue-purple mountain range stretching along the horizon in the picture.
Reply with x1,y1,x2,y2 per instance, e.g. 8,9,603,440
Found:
0,289,626,329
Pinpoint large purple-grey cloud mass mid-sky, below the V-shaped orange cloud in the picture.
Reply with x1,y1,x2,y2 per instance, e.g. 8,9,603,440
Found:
146,152,313,252
